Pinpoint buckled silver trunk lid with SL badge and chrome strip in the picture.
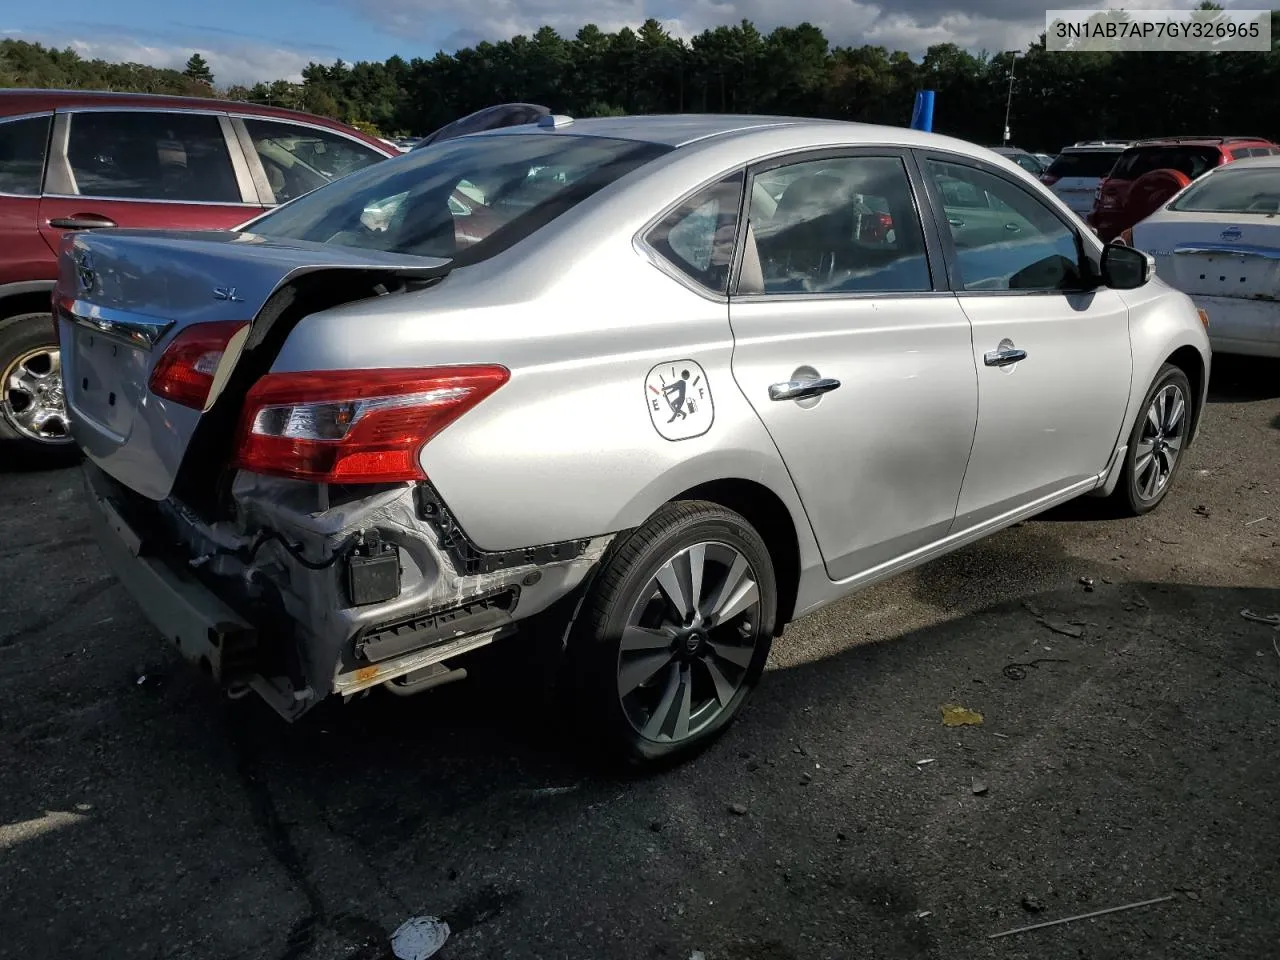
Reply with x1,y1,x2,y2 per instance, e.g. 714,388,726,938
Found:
54,230,452,500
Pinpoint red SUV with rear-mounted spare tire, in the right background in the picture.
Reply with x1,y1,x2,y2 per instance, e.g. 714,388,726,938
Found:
1088,137,1280,242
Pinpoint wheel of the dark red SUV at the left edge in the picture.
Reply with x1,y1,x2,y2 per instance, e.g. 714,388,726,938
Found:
0,312,78,466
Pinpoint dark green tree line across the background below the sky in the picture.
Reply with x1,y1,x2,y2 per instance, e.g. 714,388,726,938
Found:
0,5,1280,152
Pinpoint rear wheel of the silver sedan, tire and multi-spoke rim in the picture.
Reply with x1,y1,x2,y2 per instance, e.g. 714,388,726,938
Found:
570,502,777,762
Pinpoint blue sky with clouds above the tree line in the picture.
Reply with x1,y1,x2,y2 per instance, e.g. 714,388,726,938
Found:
0,0,1280,86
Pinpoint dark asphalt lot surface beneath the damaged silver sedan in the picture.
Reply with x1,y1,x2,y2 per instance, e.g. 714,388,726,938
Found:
0,358,1280,960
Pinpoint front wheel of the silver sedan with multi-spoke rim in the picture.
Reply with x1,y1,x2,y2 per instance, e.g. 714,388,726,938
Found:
1116,364,1194,513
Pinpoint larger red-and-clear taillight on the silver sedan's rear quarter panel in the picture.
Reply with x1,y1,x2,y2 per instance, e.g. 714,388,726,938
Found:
236,365,511,484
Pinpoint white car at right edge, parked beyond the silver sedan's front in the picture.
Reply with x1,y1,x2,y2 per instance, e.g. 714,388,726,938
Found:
1120,156,1280,358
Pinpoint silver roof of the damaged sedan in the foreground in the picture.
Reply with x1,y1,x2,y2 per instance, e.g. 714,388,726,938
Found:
481,114,1023,156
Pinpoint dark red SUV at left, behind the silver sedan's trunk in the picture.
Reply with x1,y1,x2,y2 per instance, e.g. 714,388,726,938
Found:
0,90,398,461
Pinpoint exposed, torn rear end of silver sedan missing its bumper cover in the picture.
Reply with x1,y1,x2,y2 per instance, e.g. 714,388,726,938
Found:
84,462,612,721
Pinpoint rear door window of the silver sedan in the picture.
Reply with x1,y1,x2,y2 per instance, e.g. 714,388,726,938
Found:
740,156,932,294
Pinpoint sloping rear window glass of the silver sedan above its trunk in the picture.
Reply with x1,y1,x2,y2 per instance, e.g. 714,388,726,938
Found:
246,134,671,264
